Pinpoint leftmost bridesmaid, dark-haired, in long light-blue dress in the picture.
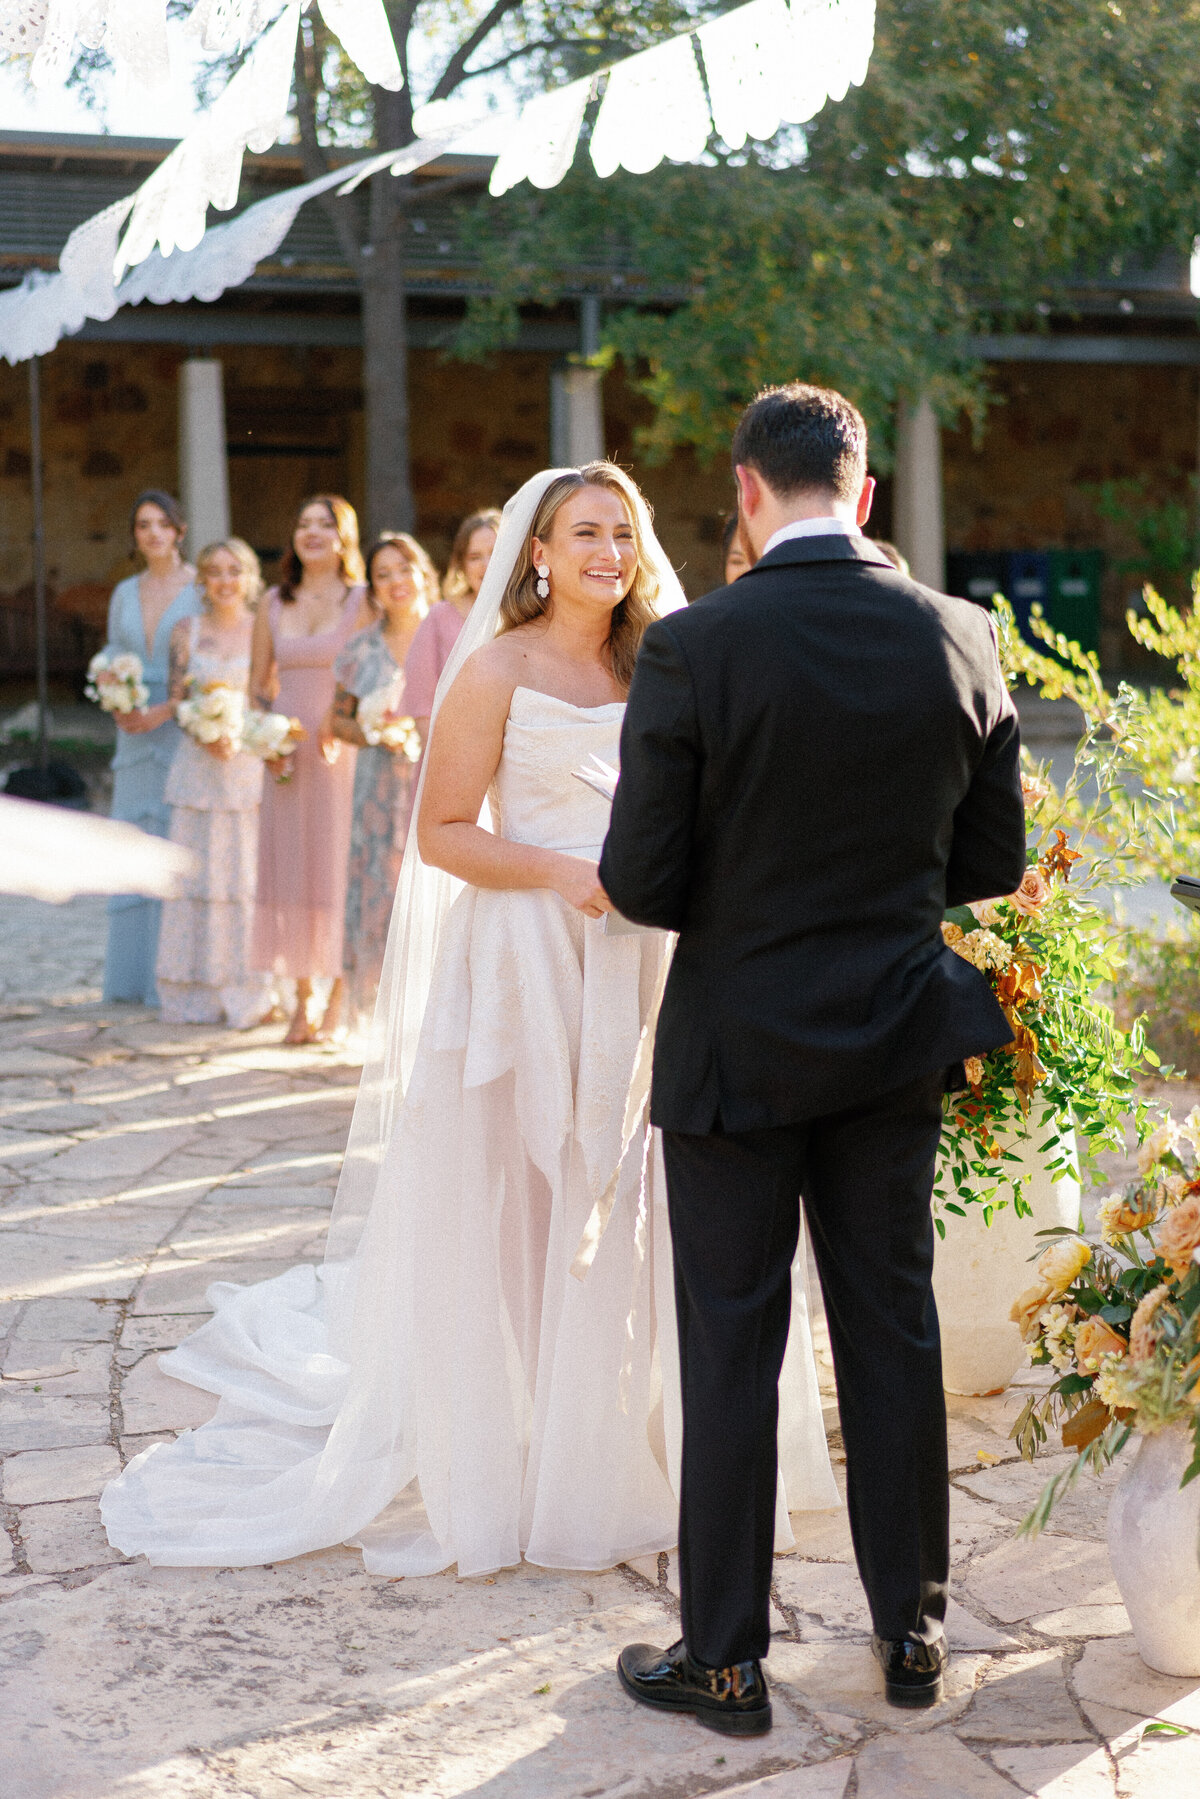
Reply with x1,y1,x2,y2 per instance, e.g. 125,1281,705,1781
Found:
104,488,200,1006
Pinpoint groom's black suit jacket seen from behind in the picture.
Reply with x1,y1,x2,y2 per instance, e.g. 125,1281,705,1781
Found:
599,534,1025,1133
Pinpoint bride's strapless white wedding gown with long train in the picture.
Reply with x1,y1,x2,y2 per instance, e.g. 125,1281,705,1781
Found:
103,669,838,1574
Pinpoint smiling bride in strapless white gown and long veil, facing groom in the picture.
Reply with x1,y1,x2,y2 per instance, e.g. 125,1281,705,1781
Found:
101,462,838,1574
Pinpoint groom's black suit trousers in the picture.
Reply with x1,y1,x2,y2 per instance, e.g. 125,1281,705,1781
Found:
662,1074,950,1668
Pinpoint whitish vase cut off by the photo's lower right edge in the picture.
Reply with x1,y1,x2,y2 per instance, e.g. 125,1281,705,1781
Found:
1108,1425,1200,1675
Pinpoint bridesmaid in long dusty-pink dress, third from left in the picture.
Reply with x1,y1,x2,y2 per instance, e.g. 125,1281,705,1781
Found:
250,493,371,1043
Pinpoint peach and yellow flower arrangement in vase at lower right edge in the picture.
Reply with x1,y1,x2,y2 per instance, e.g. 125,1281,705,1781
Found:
1011,1106,1200,1533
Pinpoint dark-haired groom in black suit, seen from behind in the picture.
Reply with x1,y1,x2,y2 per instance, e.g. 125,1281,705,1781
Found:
599,381,1025,1734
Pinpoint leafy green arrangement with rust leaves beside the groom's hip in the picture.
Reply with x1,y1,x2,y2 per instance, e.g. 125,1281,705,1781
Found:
934,601,1162,1236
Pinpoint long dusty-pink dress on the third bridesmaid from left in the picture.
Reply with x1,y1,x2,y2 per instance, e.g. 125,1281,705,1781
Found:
252,586,363,979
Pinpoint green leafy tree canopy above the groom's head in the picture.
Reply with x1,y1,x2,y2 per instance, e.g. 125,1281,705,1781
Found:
459,0,1200,466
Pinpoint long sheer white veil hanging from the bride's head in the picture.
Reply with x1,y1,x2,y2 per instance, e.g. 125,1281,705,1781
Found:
326,466,687,1268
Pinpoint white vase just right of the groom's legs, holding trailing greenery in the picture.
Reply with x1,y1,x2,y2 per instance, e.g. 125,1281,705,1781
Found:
934,1124,1079,1394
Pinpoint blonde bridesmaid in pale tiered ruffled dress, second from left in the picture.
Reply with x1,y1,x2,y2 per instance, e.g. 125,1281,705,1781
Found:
158,538,270,1031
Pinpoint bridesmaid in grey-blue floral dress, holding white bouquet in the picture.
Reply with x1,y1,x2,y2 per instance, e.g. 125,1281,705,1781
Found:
333,531,437,1025
